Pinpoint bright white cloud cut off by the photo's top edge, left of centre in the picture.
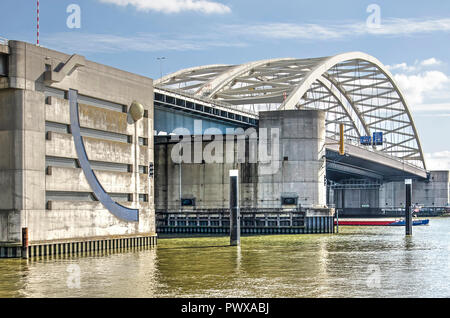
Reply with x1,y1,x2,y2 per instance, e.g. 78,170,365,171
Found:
99,0,231,14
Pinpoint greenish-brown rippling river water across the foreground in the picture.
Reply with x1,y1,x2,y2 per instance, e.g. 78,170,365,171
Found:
0,218,450,297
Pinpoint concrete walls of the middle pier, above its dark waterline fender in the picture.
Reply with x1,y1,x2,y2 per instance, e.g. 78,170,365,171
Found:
155,111,326,211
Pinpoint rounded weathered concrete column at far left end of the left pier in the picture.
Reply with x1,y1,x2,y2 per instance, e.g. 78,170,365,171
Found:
0,89,45,241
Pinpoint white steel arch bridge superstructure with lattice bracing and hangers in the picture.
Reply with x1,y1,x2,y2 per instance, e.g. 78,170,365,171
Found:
155,52,426,170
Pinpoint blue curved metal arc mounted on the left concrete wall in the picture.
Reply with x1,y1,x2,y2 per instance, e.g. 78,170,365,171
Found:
69,89,139,222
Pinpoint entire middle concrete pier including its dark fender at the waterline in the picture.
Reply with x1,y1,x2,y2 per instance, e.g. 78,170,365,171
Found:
155,110,334,234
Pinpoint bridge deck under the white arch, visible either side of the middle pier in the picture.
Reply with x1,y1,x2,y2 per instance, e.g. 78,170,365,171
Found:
155,88,427,180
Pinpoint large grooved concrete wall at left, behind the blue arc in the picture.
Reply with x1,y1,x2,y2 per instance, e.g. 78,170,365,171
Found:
0,41,155,242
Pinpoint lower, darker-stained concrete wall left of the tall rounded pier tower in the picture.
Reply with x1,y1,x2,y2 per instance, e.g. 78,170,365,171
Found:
155,138,257,211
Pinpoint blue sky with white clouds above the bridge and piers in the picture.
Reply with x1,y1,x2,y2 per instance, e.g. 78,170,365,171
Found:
0,0,450,170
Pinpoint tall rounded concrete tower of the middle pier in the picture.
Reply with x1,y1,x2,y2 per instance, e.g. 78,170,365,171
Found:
258,110,326,207
